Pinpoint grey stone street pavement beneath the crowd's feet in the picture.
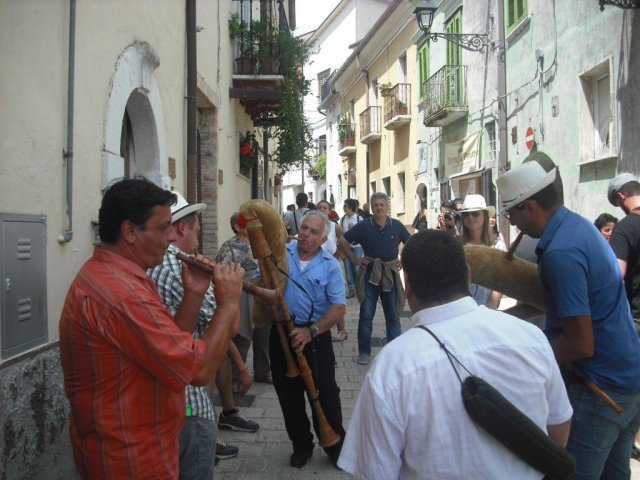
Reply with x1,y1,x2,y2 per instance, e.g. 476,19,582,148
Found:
214,298,640,480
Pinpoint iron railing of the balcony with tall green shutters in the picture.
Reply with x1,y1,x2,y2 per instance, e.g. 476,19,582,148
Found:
423,65,467,118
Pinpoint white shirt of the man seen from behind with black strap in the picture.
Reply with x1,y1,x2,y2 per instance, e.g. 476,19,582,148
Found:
338,297,573,480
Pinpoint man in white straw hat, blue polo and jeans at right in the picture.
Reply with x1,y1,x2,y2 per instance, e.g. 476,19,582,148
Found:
496,158,640,479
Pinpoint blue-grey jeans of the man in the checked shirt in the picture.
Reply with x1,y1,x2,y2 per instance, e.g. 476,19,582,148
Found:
179,417,218,480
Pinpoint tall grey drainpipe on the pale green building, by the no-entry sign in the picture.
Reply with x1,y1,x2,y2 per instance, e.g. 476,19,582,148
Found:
496,0,509,244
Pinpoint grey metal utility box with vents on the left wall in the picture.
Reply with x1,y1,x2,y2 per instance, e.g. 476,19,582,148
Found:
0,213,47,358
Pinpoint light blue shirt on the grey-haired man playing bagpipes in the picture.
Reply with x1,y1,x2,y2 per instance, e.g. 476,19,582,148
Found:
284,242,347,325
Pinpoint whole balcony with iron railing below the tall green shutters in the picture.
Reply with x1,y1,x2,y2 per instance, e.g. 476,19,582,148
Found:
421,65,469,127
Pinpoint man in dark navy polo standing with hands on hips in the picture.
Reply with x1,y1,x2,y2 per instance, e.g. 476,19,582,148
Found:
338,192,409,365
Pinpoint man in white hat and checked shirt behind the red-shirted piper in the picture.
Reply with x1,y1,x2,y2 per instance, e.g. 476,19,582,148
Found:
148,192,258,480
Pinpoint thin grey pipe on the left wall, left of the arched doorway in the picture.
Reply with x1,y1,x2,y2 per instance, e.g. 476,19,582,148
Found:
58,0,76,243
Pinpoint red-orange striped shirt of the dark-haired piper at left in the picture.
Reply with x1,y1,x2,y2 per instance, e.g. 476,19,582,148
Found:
60,247,206,479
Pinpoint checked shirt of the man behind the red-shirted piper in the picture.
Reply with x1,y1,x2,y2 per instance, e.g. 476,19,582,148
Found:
149,245,216,420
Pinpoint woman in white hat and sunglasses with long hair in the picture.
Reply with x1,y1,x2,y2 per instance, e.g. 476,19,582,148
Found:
460,194,507,309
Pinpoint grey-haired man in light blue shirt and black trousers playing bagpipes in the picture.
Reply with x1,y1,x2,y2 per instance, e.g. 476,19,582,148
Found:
269,210,346,468
